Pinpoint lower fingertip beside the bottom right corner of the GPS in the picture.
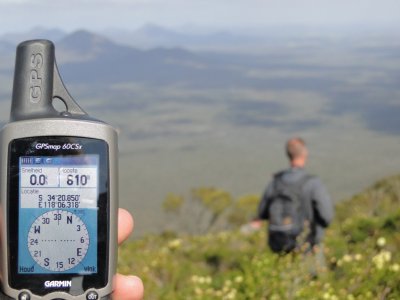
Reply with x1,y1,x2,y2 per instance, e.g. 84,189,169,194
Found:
112,274,144,300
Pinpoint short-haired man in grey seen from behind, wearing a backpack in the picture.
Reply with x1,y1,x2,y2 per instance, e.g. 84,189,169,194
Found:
258,137,334,272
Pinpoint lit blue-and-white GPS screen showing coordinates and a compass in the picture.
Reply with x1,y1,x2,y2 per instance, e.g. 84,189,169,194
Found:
18,155,99,274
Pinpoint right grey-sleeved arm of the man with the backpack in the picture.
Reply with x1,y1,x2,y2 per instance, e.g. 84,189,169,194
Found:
311,178,334,227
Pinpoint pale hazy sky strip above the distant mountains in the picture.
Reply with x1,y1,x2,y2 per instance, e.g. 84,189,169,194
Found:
0,0,400,34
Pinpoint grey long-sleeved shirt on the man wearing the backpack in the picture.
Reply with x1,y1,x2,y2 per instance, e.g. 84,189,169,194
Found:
258,168,334,245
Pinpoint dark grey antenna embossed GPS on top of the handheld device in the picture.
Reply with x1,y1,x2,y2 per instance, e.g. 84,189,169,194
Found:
10,40,87,121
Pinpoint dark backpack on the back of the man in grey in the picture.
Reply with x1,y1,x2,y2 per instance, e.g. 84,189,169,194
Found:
268,173,311,253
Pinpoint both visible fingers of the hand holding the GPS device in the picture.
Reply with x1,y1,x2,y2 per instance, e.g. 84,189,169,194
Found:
113,208,144,300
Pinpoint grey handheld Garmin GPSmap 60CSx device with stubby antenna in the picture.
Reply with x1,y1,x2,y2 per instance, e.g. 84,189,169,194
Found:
0,40,118,300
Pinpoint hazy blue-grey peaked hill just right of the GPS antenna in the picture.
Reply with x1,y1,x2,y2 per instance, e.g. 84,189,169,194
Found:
52,30,245,85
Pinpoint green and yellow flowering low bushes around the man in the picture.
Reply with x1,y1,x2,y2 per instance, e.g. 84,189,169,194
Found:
119,176,400,300
